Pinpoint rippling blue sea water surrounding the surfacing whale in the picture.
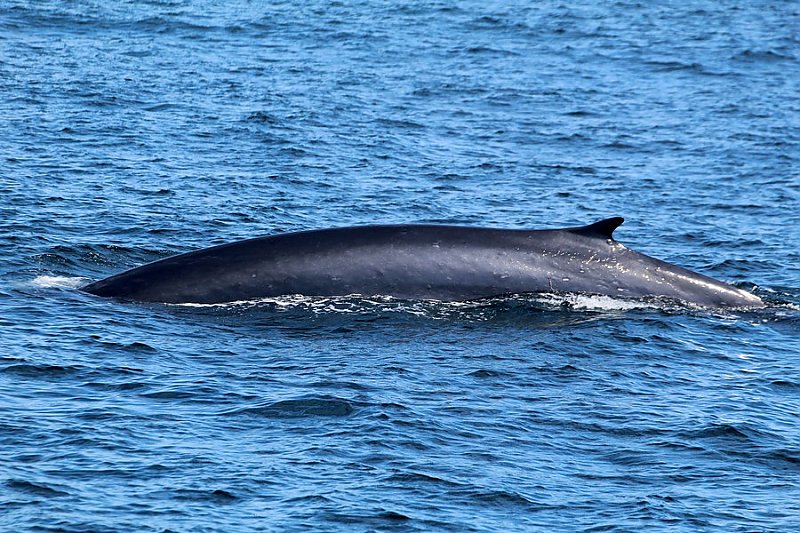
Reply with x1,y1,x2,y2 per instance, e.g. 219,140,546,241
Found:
0,0,800,532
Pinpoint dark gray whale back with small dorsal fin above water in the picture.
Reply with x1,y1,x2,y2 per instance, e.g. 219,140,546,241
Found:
82,217,764,307
